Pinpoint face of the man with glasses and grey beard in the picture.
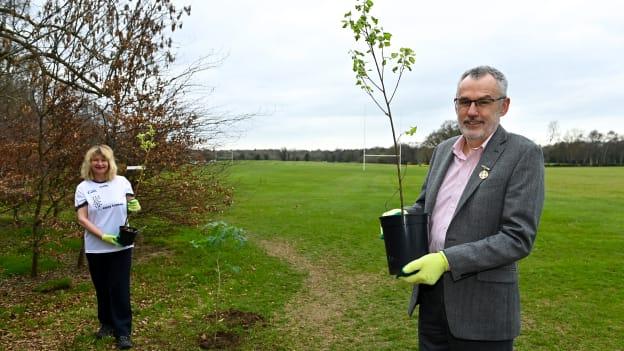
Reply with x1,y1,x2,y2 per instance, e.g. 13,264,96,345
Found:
455,74,510,148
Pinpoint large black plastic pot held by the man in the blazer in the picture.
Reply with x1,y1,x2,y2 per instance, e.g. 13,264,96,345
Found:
379,213,429,275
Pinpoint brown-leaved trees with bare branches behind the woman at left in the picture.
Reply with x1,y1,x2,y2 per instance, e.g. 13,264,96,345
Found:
0,0,244,276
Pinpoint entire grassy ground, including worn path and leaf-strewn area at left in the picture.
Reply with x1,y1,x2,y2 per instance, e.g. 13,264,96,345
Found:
0,161,624,350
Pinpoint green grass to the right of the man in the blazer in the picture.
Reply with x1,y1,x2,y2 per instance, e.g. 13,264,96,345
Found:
519,168,624,350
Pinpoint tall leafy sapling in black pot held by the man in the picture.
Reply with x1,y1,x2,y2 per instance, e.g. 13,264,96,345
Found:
342,0,428,275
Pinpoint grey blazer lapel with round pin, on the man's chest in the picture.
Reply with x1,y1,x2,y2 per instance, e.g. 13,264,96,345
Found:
453,125,507,217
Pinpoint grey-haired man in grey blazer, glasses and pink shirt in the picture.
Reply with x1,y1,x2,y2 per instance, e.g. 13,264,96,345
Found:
401,66,544,351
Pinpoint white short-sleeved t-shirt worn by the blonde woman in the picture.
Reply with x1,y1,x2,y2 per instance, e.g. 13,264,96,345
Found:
74,175,134,253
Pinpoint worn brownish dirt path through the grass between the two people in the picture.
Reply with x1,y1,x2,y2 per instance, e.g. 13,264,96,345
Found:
254,239,379,350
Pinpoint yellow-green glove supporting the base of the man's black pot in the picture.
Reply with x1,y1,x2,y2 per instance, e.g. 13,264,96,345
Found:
397,251,449,285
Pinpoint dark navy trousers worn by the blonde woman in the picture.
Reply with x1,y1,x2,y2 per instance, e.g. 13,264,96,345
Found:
87,248,132,337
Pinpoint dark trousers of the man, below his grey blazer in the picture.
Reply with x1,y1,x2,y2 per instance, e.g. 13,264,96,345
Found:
418,279,513,351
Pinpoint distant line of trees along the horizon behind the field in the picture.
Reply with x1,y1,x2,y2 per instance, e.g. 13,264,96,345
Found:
202,125,624,166
